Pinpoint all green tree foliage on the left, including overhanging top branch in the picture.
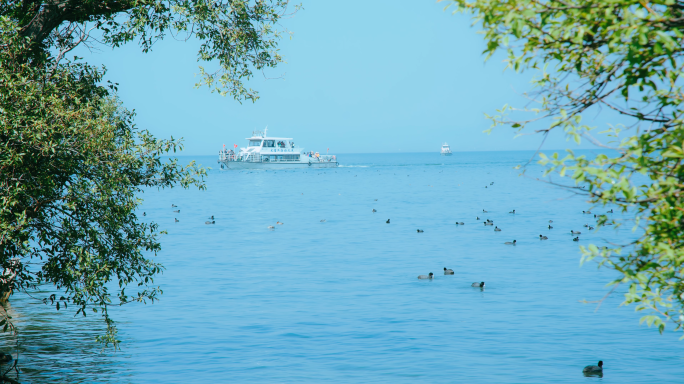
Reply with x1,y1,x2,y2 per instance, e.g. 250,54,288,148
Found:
0,0,287,346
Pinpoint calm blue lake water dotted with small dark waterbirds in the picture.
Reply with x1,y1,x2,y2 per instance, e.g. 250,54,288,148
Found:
3,152,684,383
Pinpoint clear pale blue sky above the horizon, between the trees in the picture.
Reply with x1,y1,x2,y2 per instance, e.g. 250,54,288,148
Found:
76,0,624,155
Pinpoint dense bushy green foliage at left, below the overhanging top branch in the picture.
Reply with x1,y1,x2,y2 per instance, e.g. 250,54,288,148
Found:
0,23,206,344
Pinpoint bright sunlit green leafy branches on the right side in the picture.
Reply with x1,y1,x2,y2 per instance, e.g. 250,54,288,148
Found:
450,0,684,332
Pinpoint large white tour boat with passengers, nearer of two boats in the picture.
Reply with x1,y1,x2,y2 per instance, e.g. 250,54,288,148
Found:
218,128,338,169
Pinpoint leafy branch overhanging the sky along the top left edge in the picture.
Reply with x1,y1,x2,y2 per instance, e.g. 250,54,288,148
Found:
0,0,300,101
